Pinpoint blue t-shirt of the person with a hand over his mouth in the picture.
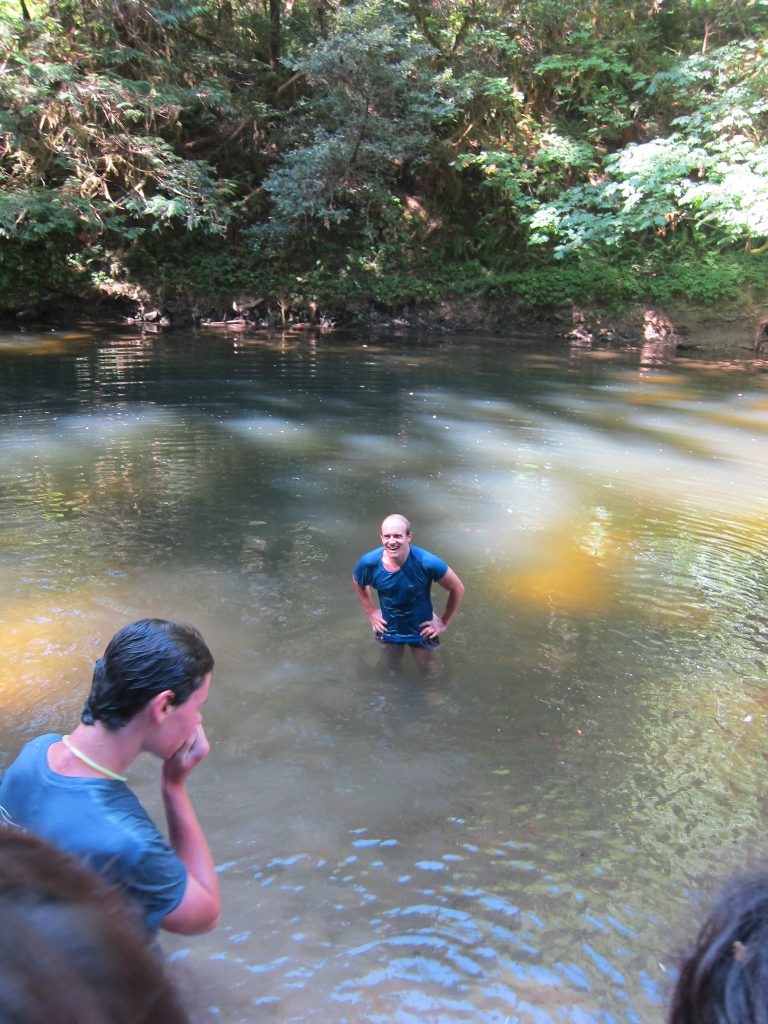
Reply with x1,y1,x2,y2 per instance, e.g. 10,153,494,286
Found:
0,733,187,931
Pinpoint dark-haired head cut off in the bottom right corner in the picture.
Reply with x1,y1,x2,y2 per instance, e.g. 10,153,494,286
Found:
669,873,768,1024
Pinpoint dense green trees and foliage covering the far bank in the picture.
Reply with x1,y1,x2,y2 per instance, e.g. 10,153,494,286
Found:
0,0,768,312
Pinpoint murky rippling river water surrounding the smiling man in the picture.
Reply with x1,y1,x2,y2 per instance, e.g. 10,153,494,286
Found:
0,329,768,1024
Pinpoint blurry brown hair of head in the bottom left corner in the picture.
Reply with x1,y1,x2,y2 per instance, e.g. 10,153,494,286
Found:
0,827,189,1024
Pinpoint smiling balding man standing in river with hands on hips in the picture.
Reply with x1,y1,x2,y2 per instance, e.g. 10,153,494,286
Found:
352,514,464,672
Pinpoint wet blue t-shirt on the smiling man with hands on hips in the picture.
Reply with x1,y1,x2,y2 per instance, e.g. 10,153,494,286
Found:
353,545,449,643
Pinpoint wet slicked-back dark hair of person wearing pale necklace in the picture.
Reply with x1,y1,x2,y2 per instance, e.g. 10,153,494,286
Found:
82,618,213,729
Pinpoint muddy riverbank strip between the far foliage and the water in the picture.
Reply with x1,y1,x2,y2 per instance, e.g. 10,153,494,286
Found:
3,290,768,360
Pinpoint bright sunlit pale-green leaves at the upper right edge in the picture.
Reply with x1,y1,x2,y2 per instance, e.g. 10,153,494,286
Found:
530,40,768,255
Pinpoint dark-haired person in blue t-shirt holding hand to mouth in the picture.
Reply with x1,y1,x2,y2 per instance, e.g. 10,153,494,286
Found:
0,618,221,935
